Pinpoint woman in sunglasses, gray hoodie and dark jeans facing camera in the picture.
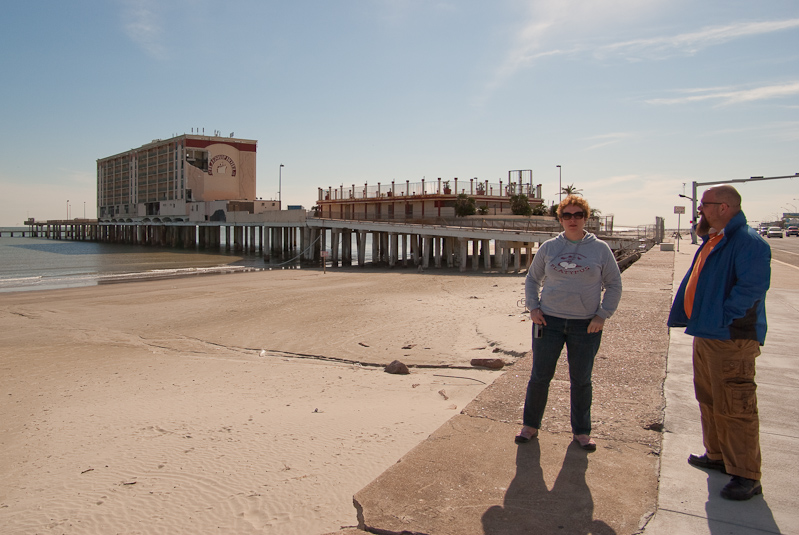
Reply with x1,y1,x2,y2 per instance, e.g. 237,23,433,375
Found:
515,195,621,451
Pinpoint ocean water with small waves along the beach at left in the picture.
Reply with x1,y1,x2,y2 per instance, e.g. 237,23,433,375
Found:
0,228,306,292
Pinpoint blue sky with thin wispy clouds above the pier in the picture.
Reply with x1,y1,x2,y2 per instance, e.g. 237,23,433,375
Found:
0,0,799,228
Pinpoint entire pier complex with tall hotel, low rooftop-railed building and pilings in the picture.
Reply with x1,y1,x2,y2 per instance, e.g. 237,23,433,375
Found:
6,128,644,272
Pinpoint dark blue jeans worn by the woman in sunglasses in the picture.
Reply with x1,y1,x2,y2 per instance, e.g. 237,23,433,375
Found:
523,315,602,435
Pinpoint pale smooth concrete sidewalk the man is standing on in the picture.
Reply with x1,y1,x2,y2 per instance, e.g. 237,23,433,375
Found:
644,244,799,535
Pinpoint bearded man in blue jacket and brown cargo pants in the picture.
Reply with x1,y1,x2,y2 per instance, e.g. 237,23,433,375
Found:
668,186,771,500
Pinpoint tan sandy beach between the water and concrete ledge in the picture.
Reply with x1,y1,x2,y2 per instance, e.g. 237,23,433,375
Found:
0,270,530,535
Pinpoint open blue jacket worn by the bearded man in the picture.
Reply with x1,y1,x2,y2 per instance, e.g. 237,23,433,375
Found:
668,212,771,345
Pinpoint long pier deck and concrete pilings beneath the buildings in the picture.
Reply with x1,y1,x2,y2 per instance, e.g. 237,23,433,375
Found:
16,211,639,272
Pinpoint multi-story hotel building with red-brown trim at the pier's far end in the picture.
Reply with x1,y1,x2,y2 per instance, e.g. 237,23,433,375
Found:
97,134,260,221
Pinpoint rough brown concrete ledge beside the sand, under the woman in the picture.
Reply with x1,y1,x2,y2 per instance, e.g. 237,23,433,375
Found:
340,251,674,535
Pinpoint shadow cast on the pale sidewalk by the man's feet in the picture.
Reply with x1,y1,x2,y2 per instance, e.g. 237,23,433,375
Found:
705,473,782,535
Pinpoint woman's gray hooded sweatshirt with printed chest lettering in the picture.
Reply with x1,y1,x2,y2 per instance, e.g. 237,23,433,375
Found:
524,232,621,319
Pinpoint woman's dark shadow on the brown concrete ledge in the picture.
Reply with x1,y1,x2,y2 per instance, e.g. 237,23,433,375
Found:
482,440,616,535
